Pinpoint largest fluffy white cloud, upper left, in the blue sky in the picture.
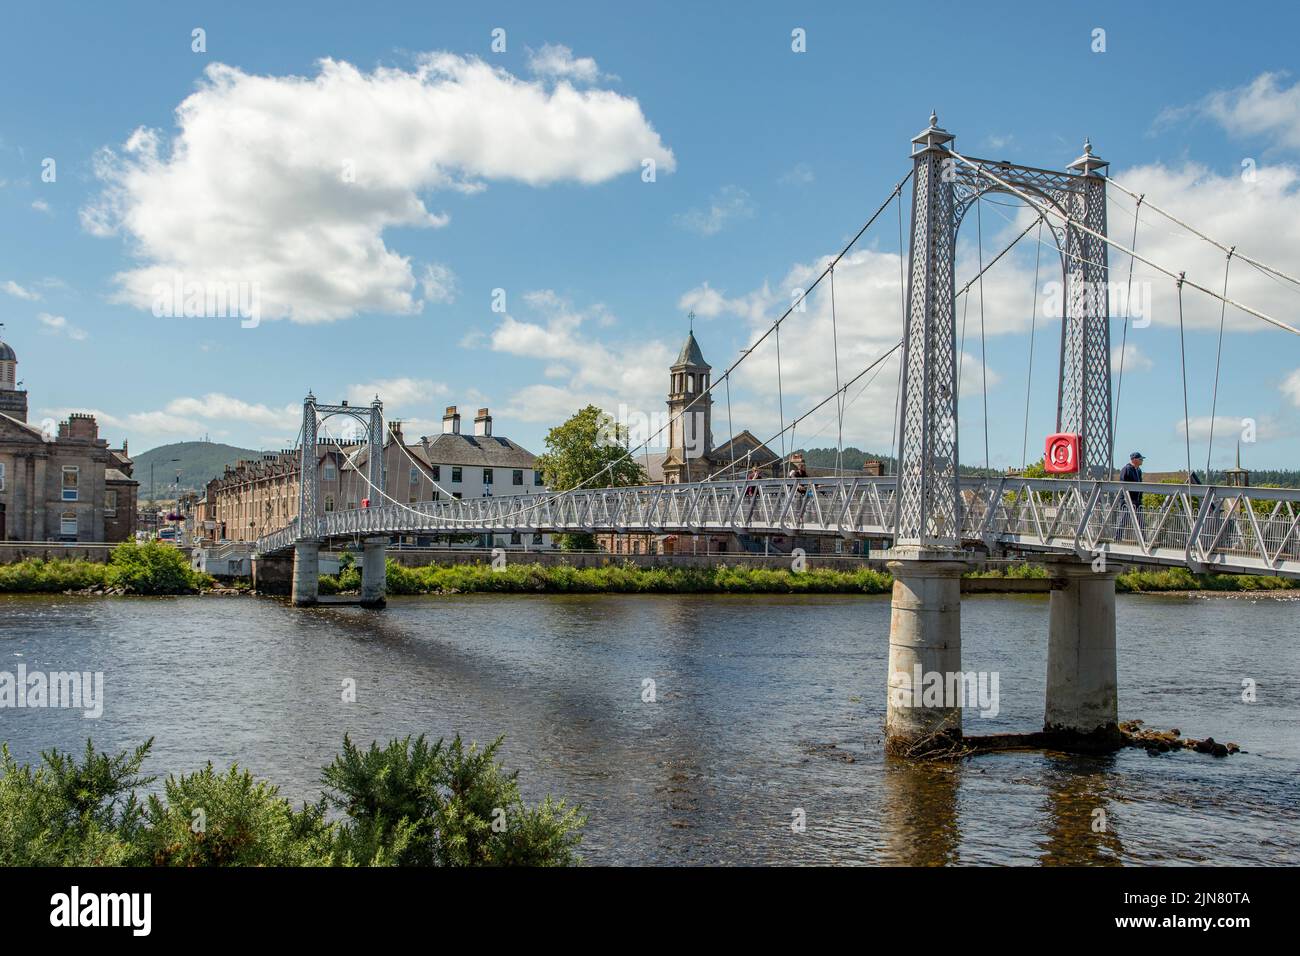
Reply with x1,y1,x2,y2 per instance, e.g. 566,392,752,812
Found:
82,53,675,323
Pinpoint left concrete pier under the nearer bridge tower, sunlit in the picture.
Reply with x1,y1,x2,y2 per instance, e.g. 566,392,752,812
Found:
885,553,966,756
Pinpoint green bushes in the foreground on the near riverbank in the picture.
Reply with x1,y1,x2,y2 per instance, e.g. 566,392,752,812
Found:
0,736,586,866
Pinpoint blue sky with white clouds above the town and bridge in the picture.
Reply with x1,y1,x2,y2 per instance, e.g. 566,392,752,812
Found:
0,3,1300,471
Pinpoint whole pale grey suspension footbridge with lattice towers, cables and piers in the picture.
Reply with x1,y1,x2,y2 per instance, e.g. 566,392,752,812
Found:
248,114,1300,752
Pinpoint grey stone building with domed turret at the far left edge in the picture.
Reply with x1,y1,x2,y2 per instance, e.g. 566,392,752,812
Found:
0,342,138,542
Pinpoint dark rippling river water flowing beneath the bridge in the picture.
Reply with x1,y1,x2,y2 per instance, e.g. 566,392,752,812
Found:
0,596,1300,865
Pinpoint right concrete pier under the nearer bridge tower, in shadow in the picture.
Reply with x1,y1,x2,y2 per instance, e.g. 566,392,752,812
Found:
1043,559,1119,747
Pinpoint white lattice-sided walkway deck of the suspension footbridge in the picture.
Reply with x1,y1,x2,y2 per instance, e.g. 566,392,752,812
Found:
256,476,1300,578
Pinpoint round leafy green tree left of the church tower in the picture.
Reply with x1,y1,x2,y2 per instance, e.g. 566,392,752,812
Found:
534,405,647,550
